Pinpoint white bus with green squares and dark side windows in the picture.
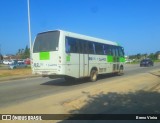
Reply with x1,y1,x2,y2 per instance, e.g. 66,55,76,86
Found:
32,30,125,81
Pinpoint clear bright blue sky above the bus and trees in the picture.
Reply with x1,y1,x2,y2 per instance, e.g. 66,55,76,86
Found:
0,0,160,55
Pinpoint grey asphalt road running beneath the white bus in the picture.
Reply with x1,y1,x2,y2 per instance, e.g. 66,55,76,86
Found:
0,63,160,108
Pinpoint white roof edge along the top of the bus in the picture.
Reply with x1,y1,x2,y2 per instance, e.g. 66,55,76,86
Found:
39,29,119,46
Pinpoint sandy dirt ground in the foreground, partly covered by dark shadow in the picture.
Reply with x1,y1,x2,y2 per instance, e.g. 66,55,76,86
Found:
0,70,160,122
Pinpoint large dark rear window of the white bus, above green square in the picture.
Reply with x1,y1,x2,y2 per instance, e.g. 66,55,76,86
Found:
33,31,60,53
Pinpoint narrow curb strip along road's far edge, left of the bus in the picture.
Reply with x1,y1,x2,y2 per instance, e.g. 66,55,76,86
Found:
0,75,41,82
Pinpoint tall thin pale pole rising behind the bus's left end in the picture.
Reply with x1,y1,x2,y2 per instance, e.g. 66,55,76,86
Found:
27,0,32,59
